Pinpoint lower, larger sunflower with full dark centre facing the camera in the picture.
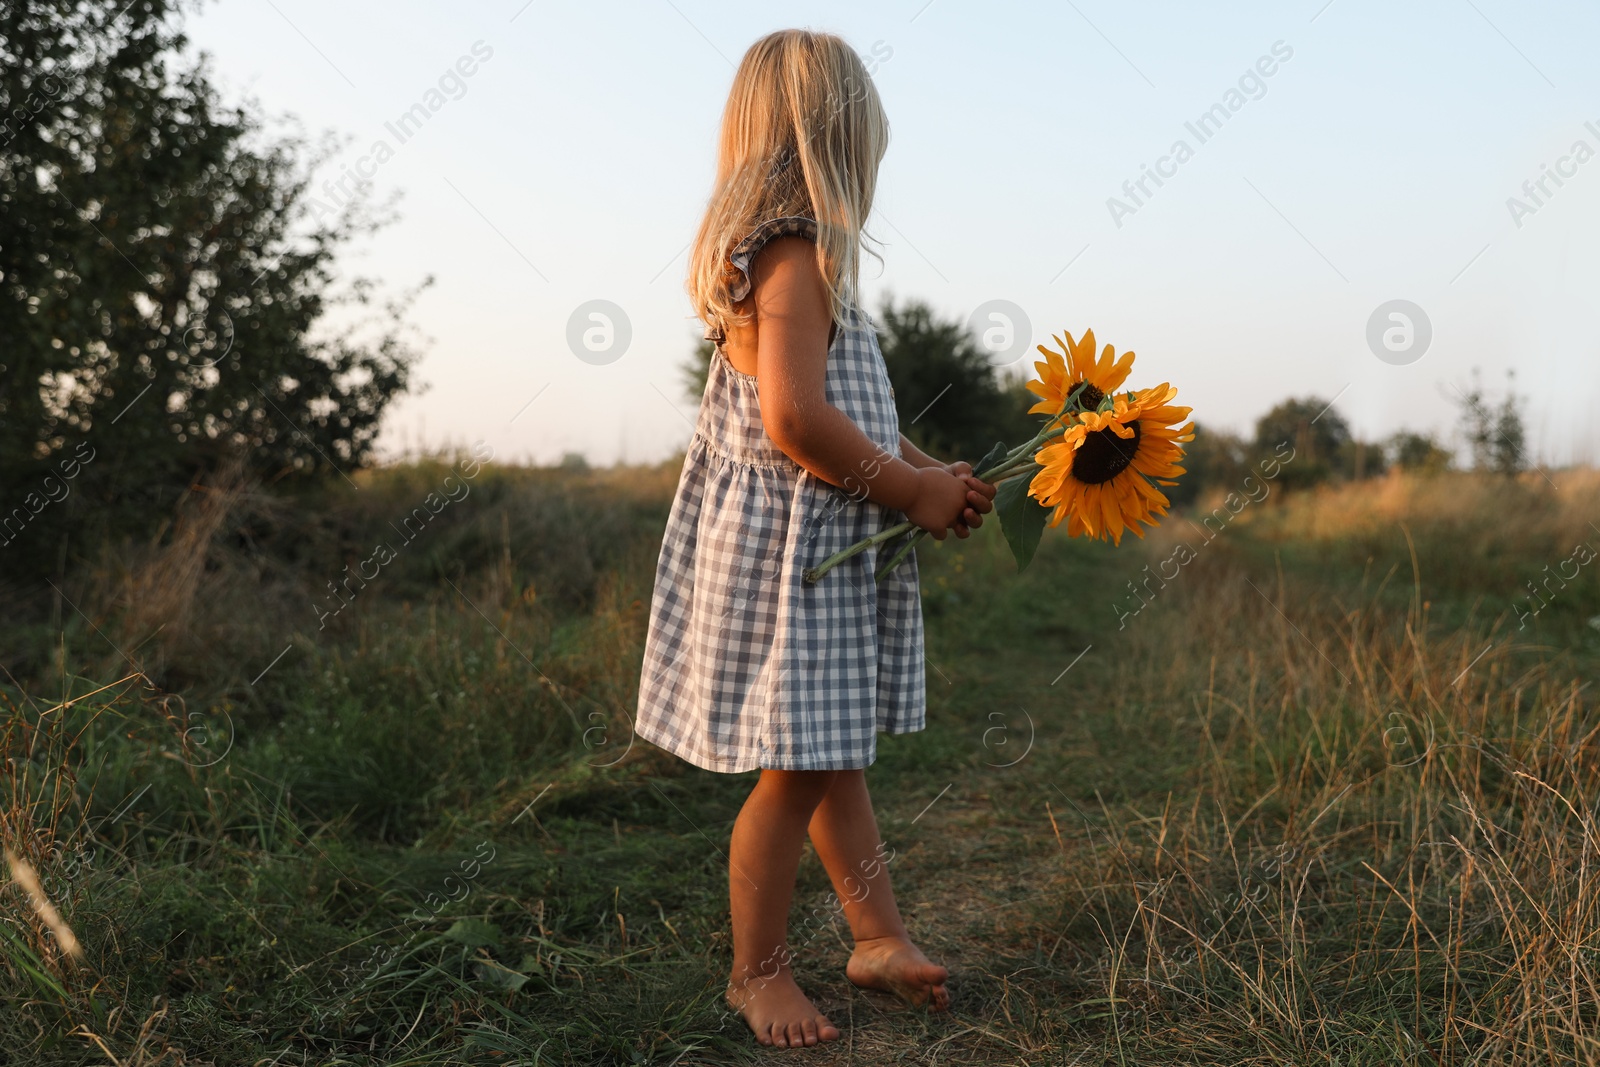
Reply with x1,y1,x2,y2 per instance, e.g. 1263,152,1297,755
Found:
1027,383,1194,544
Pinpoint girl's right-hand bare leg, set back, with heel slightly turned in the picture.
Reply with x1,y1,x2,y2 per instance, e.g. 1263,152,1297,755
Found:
810,771,950,1011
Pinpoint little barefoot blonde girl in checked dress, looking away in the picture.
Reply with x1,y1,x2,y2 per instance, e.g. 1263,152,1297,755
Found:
638,30,995,1046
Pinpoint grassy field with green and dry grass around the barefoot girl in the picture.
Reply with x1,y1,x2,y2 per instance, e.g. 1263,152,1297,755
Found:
0,458,1600,1067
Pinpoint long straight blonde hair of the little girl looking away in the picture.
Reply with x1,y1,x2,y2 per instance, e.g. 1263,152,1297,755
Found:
686,30,890,325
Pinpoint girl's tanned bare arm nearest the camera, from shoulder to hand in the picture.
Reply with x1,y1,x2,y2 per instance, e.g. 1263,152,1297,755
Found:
752,237,994,541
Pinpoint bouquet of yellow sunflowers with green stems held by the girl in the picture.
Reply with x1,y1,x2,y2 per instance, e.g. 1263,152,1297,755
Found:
805,330,1194,582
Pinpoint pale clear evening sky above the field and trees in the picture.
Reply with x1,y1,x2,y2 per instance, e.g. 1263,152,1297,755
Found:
187,0,1600,466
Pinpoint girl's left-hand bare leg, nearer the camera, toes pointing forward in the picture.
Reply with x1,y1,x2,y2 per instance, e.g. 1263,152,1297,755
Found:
728,771,838,1048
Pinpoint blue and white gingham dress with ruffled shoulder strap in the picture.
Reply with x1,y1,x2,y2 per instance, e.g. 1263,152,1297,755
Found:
637,218,926,773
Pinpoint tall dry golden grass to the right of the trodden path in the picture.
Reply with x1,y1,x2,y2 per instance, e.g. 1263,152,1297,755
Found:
1053,472,1600,1064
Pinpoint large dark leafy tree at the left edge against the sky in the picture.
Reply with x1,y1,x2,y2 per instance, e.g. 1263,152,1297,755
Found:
0,0,414,561
